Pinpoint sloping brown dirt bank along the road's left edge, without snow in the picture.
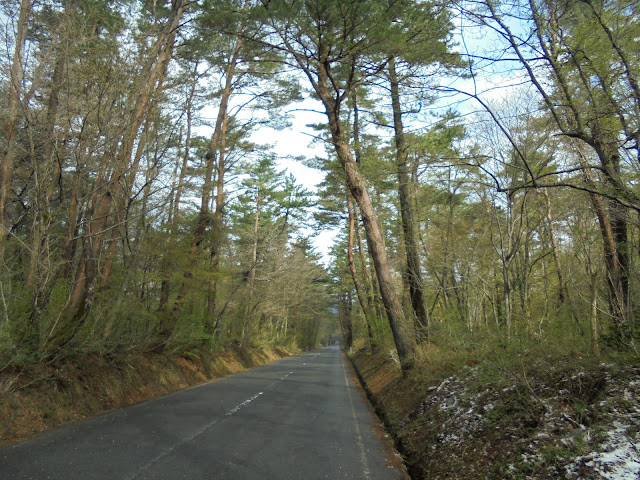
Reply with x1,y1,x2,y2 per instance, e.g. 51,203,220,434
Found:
0,346,298,445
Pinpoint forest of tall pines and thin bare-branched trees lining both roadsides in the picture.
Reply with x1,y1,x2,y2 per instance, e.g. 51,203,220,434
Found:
0,0,640,372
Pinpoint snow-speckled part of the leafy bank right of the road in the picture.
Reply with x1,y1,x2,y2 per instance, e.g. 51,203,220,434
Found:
399,364,640,480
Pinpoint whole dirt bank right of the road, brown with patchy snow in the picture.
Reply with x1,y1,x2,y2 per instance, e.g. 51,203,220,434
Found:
351,350,640,480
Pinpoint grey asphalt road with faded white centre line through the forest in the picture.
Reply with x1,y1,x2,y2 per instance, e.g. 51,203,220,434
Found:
0,347,406,480
